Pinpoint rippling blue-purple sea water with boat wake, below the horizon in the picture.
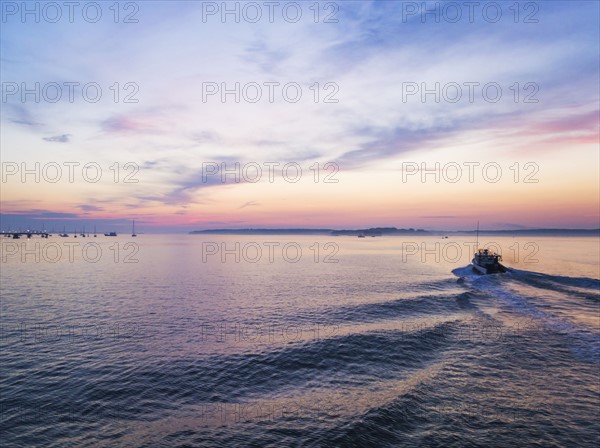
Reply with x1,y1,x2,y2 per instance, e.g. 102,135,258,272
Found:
0,235,600,447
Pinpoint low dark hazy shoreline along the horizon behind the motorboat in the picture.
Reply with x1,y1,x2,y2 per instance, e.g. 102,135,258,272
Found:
189,227,600,236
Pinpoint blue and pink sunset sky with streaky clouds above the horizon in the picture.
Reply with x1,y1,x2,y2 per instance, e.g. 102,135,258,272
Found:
0,0,600,233
